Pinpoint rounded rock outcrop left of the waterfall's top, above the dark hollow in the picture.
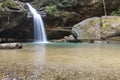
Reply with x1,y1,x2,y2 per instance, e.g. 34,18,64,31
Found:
0,0,26,32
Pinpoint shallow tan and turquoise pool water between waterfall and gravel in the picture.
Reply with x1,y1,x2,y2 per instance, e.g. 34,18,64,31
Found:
0,43,120,64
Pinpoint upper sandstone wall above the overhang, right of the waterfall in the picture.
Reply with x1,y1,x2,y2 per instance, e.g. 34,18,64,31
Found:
43,0,120,27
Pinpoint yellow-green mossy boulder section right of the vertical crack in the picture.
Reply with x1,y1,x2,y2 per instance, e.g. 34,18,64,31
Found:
101,16,120,37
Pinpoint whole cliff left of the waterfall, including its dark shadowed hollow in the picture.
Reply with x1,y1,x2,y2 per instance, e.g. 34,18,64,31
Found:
0,0,33,41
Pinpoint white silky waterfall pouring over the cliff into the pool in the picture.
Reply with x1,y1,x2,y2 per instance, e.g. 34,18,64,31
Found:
27,3,47,43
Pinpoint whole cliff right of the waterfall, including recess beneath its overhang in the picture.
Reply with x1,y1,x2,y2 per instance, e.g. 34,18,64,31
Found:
33,0,120,38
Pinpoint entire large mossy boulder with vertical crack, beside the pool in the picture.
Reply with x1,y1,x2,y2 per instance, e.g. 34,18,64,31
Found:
72,16,120,40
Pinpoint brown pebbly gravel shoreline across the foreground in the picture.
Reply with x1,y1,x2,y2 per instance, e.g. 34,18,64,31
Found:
0,63,120,80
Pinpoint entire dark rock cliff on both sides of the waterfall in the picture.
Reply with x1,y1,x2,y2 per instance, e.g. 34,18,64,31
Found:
0,0,120,40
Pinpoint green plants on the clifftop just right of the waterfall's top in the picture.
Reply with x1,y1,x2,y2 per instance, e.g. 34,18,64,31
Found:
32,0,77,16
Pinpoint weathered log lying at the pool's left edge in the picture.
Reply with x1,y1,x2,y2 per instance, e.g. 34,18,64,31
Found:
0,43,22,49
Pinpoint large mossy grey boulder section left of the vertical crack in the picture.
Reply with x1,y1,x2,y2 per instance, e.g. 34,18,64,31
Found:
72,17,101,39
